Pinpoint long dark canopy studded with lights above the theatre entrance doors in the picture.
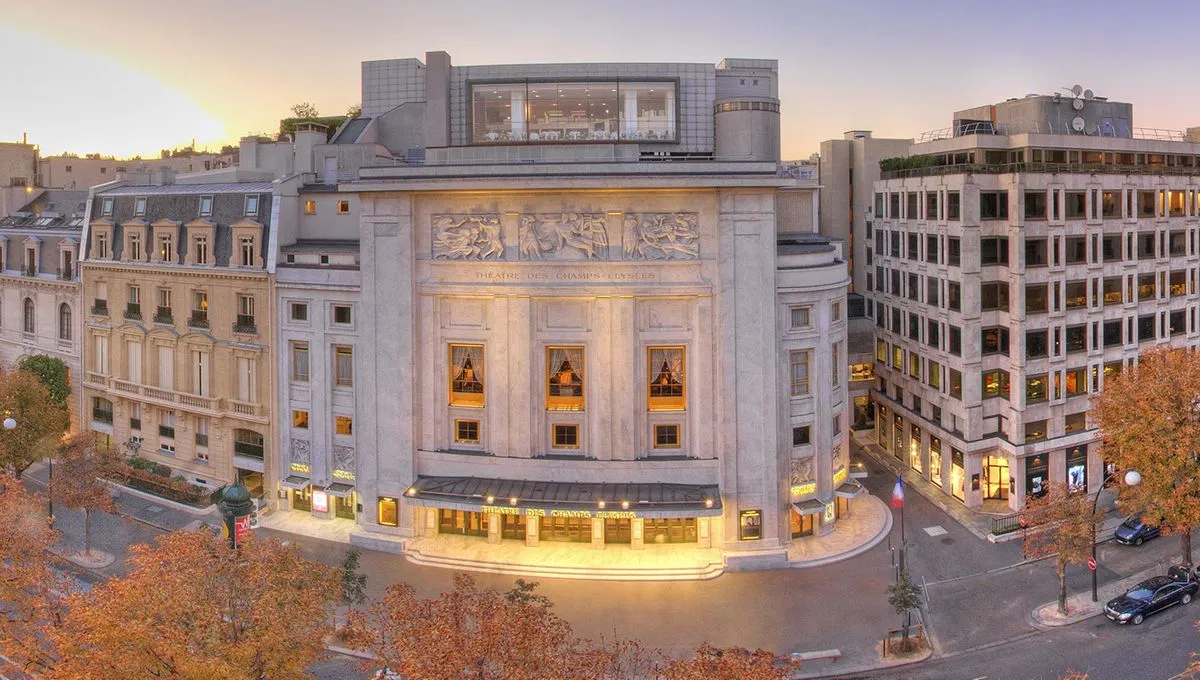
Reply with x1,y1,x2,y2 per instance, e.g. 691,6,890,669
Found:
404,475,721,517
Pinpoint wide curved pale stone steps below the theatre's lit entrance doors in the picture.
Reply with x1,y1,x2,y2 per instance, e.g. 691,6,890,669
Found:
404,546,725,580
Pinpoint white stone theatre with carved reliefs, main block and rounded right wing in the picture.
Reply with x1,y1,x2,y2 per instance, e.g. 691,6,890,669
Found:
328,53,860,568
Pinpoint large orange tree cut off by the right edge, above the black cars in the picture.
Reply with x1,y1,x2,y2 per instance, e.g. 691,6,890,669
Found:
1092,349,1200,566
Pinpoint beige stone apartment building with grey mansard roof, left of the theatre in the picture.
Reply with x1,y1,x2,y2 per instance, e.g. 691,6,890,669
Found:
82,182,274,495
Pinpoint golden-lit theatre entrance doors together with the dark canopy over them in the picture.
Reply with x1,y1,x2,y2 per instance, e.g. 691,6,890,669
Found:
403,476,721,548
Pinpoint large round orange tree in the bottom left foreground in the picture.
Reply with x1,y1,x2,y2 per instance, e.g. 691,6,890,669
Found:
54,531,340,680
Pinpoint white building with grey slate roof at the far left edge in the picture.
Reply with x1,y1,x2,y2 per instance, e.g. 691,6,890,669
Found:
0,189,88,427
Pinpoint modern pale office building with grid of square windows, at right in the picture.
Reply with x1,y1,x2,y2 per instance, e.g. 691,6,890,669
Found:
868,89,1200,511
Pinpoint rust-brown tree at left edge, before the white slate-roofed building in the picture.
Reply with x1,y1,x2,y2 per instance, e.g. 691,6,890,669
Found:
0,369,70,475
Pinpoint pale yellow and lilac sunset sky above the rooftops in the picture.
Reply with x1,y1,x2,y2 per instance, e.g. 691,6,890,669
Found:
0,0,1200,158
